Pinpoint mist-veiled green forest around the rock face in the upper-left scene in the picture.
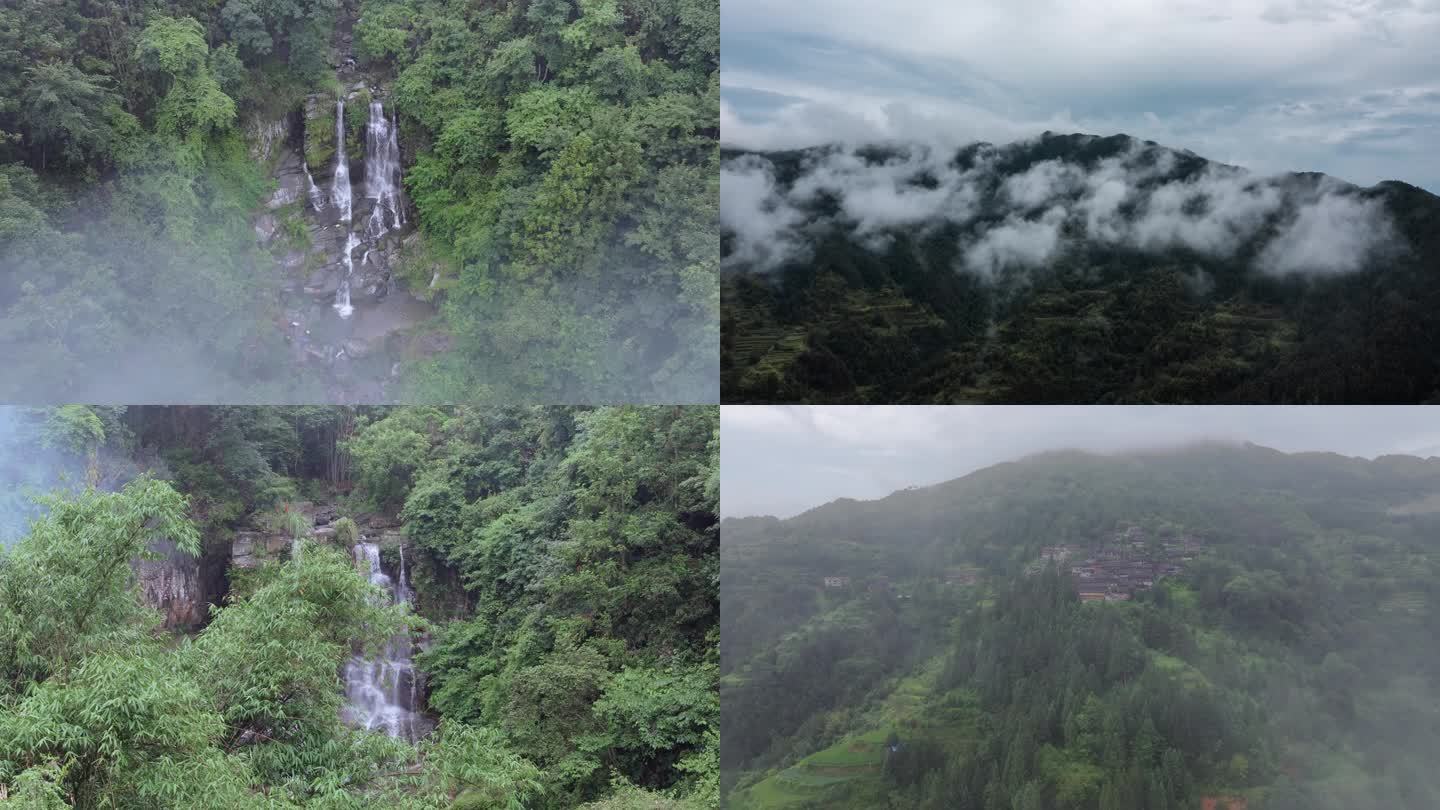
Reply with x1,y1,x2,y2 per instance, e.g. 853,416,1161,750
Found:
0,0,720,402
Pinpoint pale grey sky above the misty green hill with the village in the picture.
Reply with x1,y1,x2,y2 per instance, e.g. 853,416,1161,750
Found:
720,405,1440,517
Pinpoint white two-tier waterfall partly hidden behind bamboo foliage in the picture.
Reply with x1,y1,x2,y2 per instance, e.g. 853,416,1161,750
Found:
344,539,429,741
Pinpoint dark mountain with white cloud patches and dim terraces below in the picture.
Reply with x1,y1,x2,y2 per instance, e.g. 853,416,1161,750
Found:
721,133,1440,404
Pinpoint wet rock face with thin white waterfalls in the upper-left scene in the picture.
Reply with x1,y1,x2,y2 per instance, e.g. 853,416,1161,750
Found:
246,70,435,402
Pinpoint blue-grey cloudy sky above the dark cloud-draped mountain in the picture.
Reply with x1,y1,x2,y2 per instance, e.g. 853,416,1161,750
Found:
720,0,1440,192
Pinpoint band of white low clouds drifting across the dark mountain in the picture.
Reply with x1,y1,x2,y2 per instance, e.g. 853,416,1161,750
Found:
720,134,1395,275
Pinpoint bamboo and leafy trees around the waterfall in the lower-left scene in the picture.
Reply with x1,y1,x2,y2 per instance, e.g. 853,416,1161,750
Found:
0,405,719,810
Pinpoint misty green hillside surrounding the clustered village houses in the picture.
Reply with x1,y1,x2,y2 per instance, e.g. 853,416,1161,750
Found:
720,445,1440,810
